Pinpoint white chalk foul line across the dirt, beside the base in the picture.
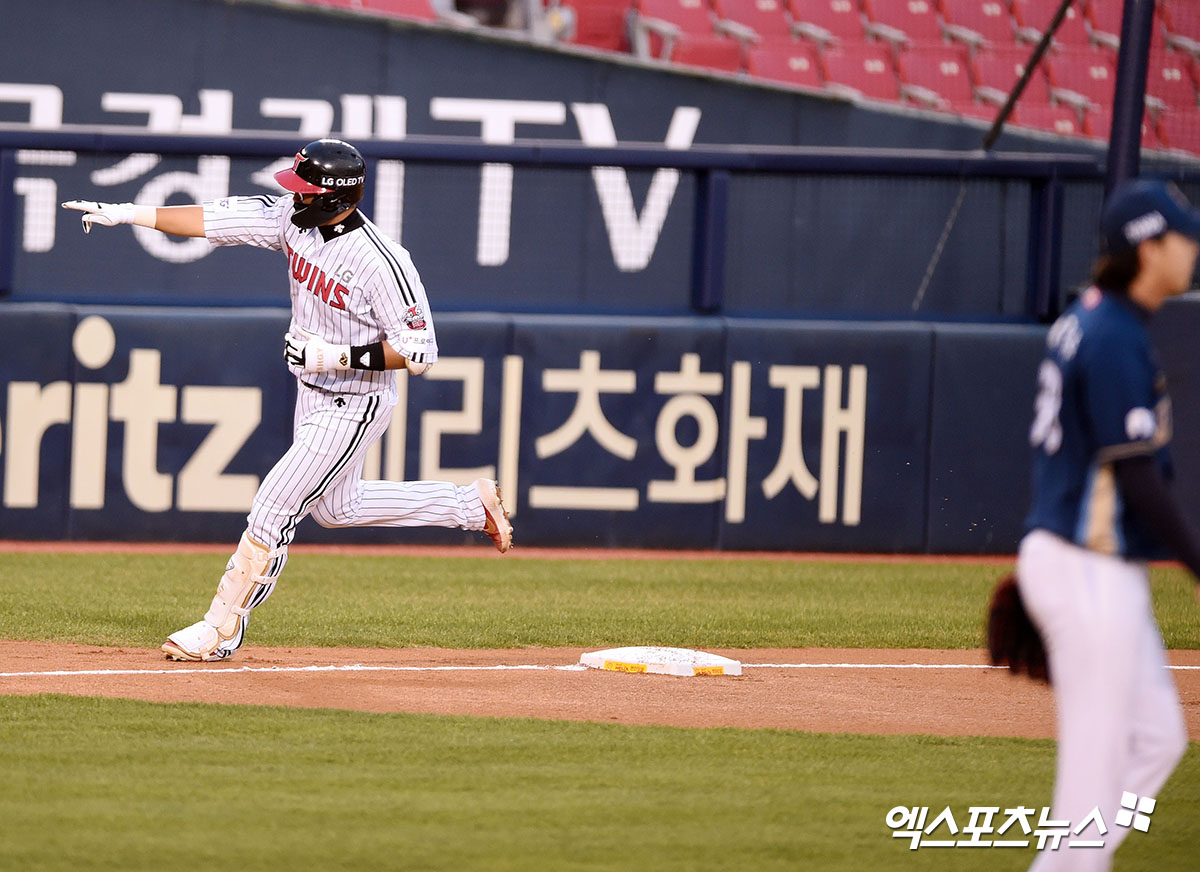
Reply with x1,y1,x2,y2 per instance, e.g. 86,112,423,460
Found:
0,663,1200,678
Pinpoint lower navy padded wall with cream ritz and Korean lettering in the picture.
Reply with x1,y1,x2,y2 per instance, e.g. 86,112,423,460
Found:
7,302,1200,553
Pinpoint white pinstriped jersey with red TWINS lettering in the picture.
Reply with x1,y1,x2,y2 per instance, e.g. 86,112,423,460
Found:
204,196,438,393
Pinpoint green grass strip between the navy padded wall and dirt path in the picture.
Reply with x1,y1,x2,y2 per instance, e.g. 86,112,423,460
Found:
0,554,1200,648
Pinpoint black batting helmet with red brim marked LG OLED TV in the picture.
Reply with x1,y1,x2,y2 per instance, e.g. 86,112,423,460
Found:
275,139,367,229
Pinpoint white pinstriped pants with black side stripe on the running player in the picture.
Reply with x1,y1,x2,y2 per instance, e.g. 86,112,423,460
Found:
246,383,487,577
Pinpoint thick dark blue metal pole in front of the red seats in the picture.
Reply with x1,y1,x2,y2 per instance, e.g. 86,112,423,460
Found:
1104,0,1154,196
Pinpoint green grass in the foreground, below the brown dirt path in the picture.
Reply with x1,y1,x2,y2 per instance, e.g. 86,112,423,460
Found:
0,696,1200,872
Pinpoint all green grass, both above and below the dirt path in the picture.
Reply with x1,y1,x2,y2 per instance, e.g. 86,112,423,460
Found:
0,554,1200,872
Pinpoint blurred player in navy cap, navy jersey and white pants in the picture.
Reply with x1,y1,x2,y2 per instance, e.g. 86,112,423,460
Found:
1018,181,1200,872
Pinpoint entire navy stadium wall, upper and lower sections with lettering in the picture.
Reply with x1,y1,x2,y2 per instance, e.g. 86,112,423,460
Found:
7,0,1200,553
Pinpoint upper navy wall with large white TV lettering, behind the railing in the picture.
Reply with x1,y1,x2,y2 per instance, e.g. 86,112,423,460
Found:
0,0,1200,320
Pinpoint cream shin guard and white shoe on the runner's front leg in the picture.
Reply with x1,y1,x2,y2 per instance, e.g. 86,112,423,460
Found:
162,534,281,661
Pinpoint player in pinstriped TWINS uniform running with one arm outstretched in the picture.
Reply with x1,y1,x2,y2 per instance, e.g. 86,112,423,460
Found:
62,139,512,661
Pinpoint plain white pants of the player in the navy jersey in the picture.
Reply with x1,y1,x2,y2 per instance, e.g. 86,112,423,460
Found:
1018,530,1188,872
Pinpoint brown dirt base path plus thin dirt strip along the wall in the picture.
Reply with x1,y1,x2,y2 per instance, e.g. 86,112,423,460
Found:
0,542,1200,741
